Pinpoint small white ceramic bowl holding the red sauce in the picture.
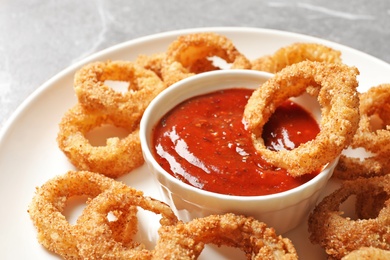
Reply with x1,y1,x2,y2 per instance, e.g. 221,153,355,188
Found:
140,70,337,234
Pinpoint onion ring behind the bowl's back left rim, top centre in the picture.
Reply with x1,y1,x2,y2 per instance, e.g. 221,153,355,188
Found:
162,32,251,86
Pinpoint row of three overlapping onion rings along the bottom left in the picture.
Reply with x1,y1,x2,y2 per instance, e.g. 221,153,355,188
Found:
29,171,298,259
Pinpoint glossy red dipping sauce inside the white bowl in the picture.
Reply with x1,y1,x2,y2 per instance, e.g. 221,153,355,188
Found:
153,88,319,196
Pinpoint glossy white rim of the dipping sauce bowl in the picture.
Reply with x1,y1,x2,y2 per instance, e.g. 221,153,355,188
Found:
140,69,338,202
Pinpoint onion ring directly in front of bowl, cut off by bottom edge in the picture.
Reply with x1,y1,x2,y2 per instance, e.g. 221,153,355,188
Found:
153,213,298,259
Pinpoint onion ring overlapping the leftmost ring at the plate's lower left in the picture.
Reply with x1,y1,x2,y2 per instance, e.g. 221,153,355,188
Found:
77,187,177,259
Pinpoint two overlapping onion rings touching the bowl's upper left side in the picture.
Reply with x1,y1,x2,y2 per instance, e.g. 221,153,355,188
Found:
57,61,166,178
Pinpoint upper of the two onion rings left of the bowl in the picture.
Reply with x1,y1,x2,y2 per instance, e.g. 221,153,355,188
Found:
74,61,165,120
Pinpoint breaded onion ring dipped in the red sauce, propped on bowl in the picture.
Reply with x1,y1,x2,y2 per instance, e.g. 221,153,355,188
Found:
244,61,359,176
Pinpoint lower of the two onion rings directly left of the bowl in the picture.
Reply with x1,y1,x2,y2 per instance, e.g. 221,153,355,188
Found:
57,104,144,178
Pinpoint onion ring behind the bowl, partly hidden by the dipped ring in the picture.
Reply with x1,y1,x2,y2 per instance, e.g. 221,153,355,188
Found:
252,43,341,73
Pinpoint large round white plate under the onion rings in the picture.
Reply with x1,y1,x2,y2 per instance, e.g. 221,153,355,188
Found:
0,28,390,259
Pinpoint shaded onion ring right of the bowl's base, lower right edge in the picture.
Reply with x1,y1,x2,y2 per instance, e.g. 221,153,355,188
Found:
308,175,390,259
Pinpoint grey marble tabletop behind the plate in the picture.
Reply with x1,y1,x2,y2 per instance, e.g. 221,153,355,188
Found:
0,0,390,127
